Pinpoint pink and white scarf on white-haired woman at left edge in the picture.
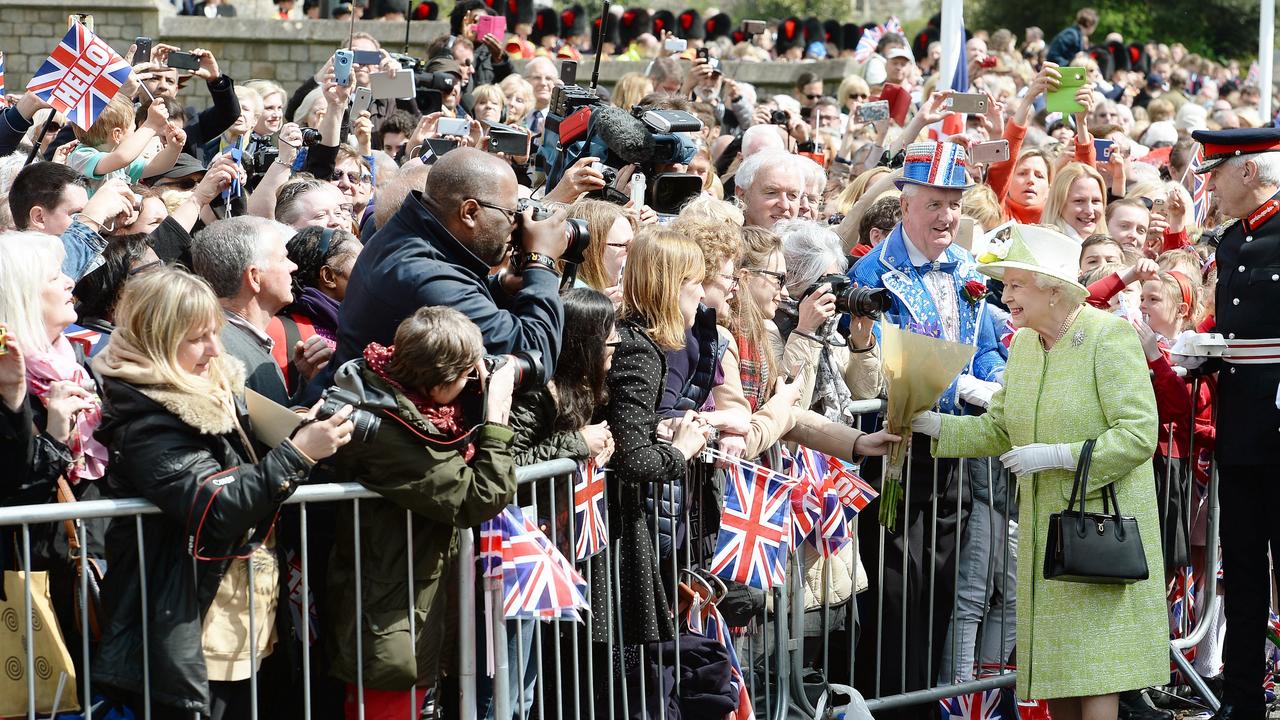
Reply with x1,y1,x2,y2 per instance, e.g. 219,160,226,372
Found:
26,334,108,484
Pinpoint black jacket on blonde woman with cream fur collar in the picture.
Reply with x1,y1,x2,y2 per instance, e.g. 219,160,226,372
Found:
93,378,311,715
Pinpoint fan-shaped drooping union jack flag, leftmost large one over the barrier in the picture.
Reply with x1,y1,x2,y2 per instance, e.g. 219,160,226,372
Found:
497,506,589,620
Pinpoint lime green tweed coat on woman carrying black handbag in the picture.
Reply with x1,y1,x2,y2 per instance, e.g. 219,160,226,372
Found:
934,306,1169,700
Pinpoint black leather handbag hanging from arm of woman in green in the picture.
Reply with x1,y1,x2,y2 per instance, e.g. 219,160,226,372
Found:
1044,439,1149,584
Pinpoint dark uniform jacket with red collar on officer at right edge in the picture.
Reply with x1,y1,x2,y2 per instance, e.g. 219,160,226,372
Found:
1215,188,1280,465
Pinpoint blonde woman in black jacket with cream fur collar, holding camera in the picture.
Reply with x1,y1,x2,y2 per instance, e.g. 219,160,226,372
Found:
93,268,353,719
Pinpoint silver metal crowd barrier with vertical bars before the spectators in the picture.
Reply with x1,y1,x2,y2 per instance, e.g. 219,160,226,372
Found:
0,386,1220,720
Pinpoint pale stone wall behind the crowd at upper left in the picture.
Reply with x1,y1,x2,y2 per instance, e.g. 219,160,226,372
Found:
0,0,852,113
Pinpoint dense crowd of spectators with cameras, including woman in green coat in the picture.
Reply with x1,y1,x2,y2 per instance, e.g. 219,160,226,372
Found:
0,0,1280,720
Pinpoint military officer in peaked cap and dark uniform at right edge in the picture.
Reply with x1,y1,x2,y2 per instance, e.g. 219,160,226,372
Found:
1192,128,1280,720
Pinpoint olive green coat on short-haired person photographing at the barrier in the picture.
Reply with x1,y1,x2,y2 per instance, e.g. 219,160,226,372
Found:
325,370,516,691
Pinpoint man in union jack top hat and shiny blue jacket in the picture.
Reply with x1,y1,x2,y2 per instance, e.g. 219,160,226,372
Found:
849,141,1005,717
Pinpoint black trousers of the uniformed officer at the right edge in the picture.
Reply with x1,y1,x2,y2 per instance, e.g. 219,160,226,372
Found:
1217,462,1280,719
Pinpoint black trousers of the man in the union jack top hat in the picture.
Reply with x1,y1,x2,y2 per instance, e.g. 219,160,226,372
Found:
854,436,970,719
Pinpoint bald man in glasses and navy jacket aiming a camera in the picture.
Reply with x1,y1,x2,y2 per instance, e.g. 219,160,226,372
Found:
311,147,566,395
